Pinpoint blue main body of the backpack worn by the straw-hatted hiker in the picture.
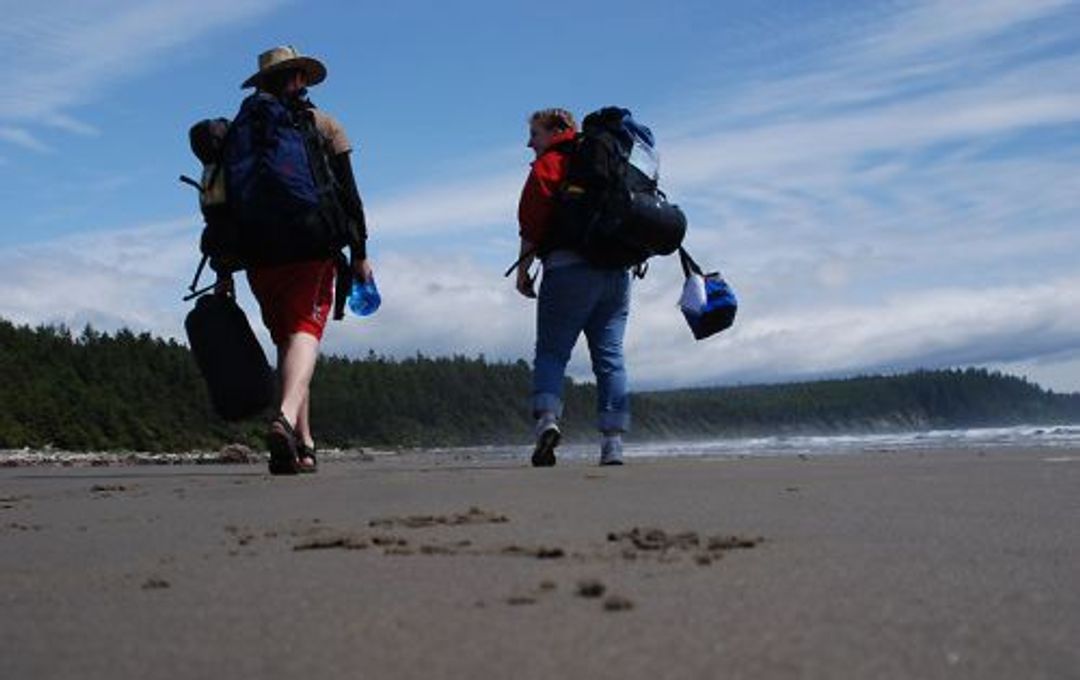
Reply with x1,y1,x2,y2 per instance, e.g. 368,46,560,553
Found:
221,93,348,263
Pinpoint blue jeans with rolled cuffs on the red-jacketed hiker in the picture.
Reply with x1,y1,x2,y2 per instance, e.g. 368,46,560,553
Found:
532,263,630,432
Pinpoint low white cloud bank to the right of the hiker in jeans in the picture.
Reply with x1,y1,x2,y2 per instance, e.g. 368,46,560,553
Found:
630,272,1080,389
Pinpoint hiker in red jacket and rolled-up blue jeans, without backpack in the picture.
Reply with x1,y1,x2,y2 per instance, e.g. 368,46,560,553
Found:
516,109,630,467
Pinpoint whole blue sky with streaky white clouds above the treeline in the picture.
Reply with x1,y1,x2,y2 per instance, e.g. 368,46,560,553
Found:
0,0,1080,391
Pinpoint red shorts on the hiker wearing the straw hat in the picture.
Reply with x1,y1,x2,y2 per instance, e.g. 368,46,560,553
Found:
247,259,336,345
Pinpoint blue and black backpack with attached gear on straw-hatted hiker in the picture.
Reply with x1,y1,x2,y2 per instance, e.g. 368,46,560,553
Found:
180,93,352,319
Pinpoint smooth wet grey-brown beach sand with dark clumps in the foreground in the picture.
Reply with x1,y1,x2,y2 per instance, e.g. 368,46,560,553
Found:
0,449,1080,680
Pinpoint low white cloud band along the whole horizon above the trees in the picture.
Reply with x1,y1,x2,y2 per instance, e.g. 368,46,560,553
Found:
0,218,1080,389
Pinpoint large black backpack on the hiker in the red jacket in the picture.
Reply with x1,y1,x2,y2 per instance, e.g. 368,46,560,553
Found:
540,107,686,268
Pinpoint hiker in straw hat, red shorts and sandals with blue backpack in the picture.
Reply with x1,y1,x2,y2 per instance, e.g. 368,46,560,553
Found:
218,46,373,474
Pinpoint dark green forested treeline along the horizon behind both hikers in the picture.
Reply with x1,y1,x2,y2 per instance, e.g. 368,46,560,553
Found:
0,319,1080,451
